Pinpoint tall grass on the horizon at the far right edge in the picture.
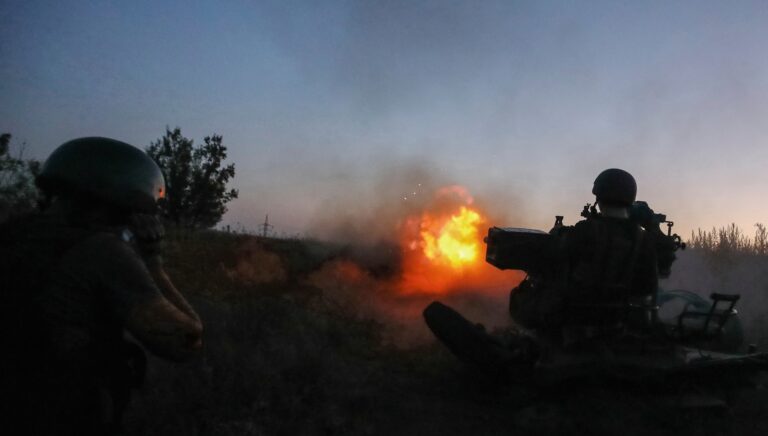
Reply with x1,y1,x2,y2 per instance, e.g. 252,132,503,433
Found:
688,223,768,256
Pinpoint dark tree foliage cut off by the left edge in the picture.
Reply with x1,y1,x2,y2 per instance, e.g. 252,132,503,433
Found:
0,133,40,222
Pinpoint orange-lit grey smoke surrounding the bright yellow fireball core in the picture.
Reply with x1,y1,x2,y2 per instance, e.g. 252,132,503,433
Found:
296,160,522,347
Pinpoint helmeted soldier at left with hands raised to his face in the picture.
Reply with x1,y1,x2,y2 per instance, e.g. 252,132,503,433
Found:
0,137,202,435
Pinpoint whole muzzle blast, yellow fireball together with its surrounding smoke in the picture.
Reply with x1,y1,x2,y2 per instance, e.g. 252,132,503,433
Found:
308,164,522,346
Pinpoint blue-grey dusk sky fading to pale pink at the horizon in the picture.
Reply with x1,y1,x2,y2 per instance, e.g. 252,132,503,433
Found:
0,0,768,237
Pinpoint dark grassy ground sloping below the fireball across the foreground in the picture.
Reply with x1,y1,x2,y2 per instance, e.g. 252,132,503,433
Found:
126,232,768,436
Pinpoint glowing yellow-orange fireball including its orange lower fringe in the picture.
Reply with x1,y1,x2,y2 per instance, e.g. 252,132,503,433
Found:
400,186,519,294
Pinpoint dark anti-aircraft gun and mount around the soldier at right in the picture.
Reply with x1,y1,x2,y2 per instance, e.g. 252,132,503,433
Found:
424,202,768,408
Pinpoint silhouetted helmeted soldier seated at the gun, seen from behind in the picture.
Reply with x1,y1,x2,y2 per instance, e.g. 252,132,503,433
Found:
510,168,658,346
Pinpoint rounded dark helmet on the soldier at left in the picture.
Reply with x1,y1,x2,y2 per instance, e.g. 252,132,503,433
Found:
35,137,165,212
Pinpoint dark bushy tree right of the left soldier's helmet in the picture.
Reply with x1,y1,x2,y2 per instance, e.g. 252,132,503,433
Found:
147,127,237,228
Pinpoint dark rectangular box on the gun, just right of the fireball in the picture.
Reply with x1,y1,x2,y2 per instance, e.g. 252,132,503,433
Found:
485,227,552,271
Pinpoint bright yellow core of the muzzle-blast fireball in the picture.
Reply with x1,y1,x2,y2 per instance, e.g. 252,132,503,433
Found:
421,206,482,268
